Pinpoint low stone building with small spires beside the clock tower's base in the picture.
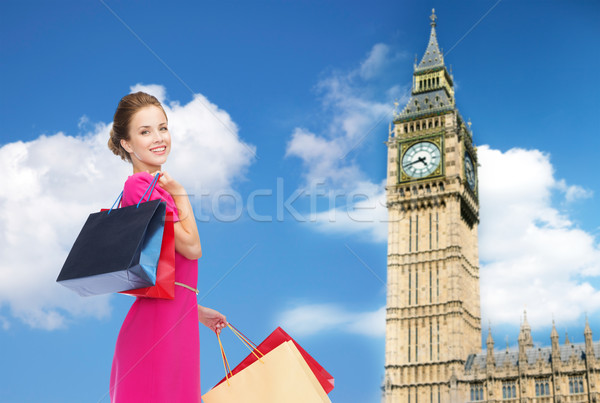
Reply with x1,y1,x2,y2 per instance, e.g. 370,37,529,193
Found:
461,316,600,403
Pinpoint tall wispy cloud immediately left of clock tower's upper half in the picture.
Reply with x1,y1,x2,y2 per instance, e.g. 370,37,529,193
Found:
286,44,406,241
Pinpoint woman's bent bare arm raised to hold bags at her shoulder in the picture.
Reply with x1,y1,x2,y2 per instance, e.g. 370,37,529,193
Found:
152,171,202,260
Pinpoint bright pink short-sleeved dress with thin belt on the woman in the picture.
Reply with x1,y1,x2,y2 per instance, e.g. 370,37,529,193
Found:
110,172,200,403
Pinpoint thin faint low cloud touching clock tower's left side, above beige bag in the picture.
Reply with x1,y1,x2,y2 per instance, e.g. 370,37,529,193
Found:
277,304,385,337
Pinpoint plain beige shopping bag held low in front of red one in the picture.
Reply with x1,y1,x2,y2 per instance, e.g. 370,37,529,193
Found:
202,341,331,403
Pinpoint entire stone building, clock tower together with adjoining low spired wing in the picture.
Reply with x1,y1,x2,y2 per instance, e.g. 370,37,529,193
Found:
382,9,600,403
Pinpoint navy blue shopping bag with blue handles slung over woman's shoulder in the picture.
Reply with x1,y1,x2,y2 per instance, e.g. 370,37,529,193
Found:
56,175,166,296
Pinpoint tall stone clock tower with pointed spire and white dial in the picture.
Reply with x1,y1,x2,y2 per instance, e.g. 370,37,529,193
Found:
383,11,481,403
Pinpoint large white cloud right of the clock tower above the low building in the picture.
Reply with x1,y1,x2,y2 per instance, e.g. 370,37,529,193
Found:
478,146,600,325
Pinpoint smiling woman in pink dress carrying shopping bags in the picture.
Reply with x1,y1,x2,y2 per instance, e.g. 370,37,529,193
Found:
108,92,227,403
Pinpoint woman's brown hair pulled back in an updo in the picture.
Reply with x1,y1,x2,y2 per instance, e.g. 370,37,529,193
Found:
108,92,167,162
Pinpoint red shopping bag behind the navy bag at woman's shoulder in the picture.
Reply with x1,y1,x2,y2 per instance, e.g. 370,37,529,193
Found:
116,211,175,299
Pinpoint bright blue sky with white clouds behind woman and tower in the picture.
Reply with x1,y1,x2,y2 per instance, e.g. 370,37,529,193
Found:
0,0,600,403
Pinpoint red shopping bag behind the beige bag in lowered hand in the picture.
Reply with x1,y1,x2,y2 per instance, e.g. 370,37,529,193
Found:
215,327,334,393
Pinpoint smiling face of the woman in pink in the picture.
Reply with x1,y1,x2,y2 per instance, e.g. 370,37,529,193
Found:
121,105,171,173
